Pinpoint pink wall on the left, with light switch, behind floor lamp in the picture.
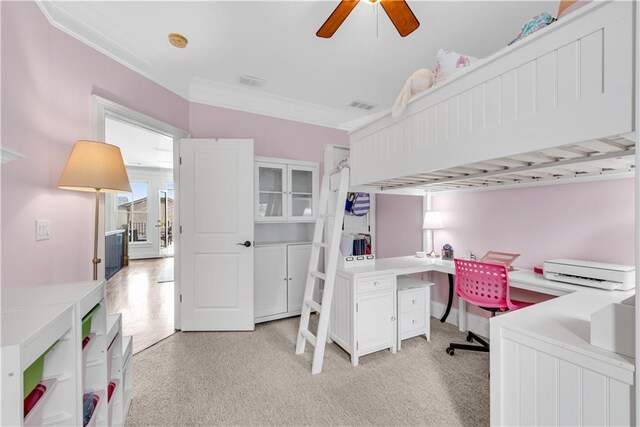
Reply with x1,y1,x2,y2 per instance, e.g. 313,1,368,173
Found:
1,2,189,287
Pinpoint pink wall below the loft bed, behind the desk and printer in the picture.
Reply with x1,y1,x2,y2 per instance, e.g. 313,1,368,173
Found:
433,178,635,315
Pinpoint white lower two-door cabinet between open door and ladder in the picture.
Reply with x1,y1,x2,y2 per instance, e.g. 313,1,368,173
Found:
253,244,311,323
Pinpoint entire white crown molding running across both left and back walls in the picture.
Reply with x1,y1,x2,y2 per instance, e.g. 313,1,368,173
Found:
36,0,370,131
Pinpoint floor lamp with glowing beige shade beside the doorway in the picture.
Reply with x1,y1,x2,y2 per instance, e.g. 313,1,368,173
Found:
58,141,131,280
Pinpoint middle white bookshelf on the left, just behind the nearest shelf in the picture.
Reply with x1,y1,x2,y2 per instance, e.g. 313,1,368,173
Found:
1,281,109,427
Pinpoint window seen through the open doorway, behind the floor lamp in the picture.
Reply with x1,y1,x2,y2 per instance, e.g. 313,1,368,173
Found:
116,182,149,243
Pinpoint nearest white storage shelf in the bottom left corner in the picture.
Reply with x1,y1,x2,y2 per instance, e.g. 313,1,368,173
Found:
0,304,77,426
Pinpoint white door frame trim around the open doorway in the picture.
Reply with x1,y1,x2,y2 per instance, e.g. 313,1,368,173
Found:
91,95,191,329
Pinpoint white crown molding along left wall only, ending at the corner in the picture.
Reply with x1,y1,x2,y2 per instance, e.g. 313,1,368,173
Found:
36,0,189,99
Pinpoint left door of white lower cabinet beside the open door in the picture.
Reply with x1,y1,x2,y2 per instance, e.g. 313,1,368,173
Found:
254,245,287,319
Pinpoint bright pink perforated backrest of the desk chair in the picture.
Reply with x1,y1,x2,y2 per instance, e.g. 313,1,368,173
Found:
454,258,515,311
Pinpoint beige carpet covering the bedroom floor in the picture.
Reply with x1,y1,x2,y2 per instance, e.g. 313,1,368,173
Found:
127,316,489,426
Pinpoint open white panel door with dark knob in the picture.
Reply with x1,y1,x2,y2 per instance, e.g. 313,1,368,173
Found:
179,139,254,331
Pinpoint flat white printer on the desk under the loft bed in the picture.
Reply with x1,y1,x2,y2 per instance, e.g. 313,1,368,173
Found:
544,259,636,291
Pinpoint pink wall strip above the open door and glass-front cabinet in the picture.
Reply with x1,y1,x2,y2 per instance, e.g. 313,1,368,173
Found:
189,103,349,174
